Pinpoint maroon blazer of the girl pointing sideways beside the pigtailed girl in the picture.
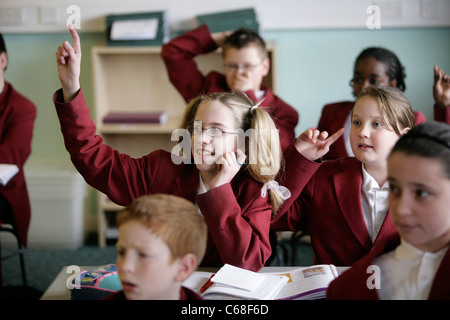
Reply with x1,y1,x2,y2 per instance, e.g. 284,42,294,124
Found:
271,146,396,266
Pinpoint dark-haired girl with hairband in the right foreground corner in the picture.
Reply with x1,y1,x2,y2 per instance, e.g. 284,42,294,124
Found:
327,122,450,300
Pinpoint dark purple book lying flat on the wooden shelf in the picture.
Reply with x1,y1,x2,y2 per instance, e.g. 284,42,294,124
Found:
103,111,168,124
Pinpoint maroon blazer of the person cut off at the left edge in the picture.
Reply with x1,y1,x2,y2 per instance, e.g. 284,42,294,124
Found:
0,82,36,246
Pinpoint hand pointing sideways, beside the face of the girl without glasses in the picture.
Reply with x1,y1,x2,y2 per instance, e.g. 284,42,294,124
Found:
295,128,345,161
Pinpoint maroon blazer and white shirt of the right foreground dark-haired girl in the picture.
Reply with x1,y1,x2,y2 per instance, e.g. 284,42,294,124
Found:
327,237,450,300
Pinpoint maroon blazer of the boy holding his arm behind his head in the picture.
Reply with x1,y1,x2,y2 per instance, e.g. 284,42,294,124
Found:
161,25,299,150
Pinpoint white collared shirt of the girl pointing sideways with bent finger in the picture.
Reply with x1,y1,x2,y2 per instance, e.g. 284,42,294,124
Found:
361,164,389,243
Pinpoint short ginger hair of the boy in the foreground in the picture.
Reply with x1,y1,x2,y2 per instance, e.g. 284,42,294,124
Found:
116,194,207,265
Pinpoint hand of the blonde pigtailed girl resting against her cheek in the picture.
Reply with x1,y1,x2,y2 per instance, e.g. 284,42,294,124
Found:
210,149,246,189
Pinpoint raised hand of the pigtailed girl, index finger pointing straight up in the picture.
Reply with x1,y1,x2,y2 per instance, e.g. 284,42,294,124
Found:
56,26,81,102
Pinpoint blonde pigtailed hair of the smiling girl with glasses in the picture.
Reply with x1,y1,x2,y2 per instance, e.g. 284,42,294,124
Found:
181,92,283,212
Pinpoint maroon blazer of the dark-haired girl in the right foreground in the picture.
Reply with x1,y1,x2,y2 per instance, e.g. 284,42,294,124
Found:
327,235,450,300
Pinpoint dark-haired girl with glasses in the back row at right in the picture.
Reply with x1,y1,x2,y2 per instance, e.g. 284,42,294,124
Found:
317,47,425,160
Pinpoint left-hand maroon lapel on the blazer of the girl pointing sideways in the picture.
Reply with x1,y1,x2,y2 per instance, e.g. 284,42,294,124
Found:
333,158,372,250
